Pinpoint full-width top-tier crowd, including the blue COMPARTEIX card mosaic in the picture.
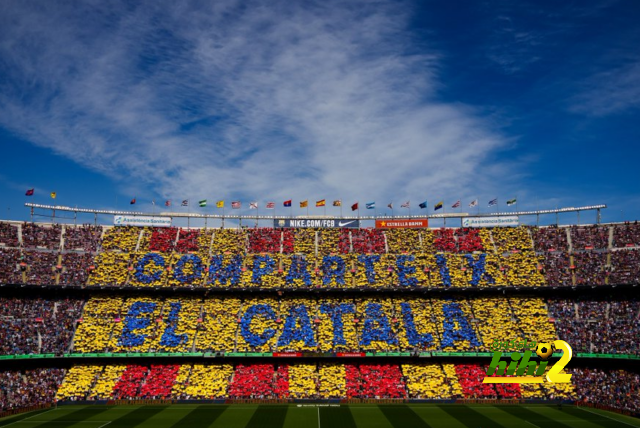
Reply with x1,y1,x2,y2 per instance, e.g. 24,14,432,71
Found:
0,223,640,289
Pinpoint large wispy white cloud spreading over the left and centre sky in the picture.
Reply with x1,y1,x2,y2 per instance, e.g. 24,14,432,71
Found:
0,1,507,207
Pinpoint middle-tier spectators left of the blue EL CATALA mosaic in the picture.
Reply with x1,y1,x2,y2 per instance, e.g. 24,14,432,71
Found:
0,297,84,355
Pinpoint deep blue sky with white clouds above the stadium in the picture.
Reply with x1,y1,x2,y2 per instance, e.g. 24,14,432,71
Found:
0,0,640,226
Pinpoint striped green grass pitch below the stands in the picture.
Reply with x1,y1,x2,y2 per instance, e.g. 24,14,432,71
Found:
0,404,640,428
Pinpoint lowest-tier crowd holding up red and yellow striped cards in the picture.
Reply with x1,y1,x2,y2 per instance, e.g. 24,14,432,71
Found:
46,363,584,402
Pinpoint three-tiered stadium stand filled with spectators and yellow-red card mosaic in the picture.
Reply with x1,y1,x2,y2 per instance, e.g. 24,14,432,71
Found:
0,222,640,411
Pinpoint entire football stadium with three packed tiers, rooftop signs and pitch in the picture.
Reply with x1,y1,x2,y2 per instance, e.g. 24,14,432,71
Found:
0,202,640,428
